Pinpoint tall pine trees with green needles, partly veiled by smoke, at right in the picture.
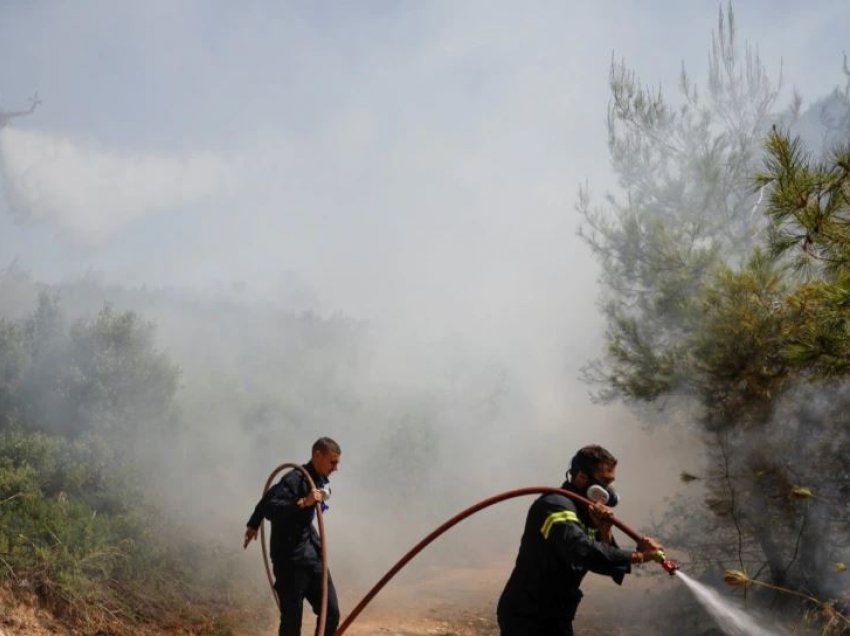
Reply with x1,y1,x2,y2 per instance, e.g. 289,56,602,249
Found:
579,3,850,633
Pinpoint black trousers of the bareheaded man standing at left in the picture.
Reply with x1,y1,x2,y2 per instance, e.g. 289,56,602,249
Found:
274,563,339,636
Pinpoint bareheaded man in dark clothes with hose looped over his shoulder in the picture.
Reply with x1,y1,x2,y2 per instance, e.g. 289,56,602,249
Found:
243,437,342,636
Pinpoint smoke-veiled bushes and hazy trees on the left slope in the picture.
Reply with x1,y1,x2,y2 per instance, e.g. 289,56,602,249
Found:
0,293,258,634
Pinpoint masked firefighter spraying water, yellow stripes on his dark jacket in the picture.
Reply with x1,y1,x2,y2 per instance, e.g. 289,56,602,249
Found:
497,445,661,636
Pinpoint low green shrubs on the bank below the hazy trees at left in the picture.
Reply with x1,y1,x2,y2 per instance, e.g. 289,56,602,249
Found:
0,432,258,634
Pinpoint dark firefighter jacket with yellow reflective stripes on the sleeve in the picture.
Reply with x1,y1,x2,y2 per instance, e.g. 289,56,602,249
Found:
498,482,631,622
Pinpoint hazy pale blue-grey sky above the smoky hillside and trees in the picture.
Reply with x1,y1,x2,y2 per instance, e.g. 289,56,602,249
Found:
0,0,850,600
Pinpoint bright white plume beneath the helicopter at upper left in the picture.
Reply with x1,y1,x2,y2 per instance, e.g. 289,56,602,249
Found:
0,128,229,246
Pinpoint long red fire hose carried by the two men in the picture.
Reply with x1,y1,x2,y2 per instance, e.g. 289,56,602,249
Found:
255,476,678,636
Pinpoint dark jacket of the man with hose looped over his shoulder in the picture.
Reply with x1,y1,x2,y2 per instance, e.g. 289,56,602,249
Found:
248,462,328,566
